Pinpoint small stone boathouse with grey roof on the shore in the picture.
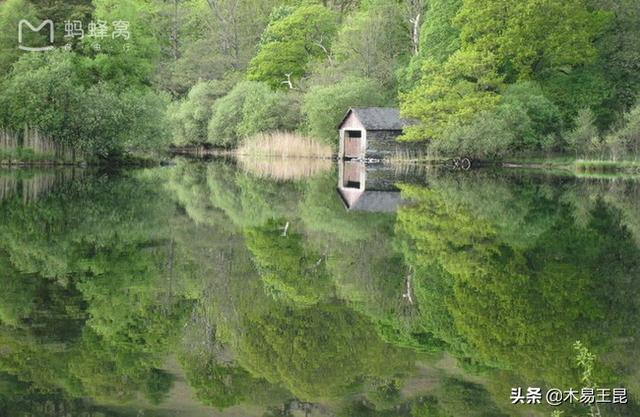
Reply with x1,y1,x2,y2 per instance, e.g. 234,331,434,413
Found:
338,107,416,159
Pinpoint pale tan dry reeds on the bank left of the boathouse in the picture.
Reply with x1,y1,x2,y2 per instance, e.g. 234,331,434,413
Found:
236,132,333,159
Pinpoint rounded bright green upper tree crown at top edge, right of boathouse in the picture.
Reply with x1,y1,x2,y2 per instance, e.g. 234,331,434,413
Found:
455,0,608,79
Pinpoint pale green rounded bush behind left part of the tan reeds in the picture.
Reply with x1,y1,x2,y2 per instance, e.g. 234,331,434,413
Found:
208,81,299,147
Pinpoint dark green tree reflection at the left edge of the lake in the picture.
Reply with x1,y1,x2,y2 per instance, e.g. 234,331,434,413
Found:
0,171,186,407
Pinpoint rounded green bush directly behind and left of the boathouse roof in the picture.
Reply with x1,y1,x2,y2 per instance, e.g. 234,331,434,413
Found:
302,78,388,145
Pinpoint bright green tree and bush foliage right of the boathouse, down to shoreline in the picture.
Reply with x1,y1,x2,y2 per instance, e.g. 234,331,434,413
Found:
400,0,611,151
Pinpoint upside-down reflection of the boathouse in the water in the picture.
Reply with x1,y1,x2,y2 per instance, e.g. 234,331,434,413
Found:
338,161,402,213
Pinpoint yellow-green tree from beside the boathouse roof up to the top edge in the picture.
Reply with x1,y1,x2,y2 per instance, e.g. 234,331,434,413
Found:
401,0,609,147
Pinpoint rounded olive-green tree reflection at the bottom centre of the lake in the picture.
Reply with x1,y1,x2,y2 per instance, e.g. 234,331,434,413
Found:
232,304,410,399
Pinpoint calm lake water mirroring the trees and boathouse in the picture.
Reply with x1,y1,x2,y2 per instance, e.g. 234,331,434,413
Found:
0,161,640,417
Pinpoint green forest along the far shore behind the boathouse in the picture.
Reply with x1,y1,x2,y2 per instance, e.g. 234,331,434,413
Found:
0,0,640,161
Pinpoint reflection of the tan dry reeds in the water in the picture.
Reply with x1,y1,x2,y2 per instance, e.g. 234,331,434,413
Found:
238,156,332,181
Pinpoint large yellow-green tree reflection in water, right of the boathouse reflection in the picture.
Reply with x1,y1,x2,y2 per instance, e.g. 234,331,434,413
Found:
397,175,640,384
